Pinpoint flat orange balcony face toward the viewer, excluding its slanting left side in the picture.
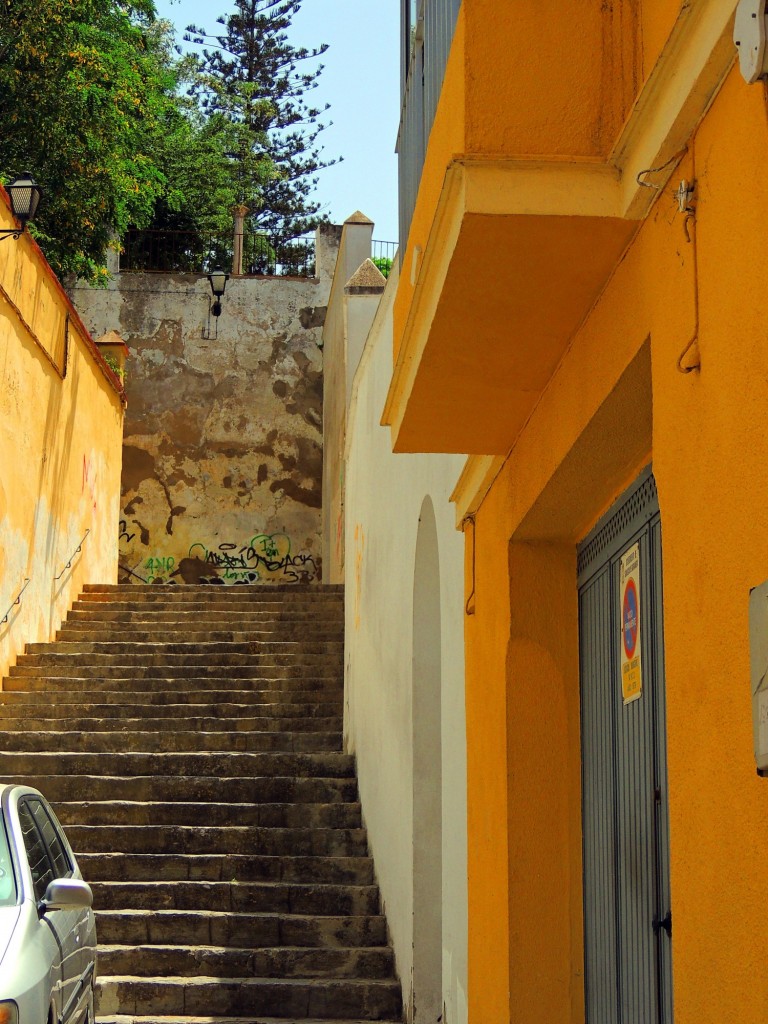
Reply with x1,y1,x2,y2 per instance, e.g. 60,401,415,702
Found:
463,0,639,159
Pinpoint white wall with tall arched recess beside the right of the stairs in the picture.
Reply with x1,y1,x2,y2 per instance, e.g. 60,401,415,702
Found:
345,264,467,1024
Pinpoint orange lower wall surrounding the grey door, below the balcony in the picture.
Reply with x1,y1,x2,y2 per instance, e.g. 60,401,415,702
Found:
466,66,768,1024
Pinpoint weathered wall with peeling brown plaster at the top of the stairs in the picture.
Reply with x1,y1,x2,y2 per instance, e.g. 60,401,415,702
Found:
74,225,339,584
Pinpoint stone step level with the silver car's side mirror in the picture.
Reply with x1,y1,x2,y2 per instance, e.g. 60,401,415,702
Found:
91,882,379,916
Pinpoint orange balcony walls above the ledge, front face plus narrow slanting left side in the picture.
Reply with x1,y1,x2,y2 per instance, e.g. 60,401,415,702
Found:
394,0,638,358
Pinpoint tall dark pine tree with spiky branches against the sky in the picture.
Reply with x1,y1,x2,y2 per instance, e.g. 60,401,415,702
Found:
184,0,336,239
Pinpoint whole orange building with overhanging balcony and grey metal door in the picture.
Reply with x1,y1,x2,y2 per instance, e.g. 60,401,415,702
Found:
391,0,768,1024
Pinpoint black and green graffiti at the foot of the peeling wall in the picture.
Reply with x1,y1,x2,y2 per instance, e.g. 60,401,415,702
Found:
135,534,319,585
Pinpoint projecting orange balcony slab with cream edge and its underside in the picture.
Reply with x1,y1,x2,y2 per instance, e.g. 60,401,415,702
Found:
383,160,637,455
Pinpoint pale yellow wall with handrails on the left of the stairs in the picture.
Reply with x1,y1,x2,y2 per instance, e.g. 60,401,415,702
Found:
0,193,123,678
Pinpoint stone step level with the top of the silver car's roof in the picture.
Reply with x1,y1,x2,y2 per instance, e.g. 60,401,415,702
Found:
2,774,357,806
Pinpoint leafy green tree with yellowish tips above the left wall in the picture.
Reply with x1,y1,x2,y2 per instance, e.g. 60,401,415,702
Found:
0,0,175,282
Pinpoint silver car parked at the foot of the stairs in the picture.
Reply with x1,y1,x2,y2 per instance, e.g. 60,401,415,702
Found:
0,785,96,1024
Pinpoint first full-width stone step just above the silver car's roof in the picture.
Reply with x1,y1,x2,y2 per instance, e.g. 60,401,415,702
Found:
0,751,354,778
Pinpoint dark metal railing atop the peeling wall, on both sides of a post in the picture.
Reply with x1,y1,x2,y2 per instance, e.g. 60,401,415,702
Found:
120,228,315,278
